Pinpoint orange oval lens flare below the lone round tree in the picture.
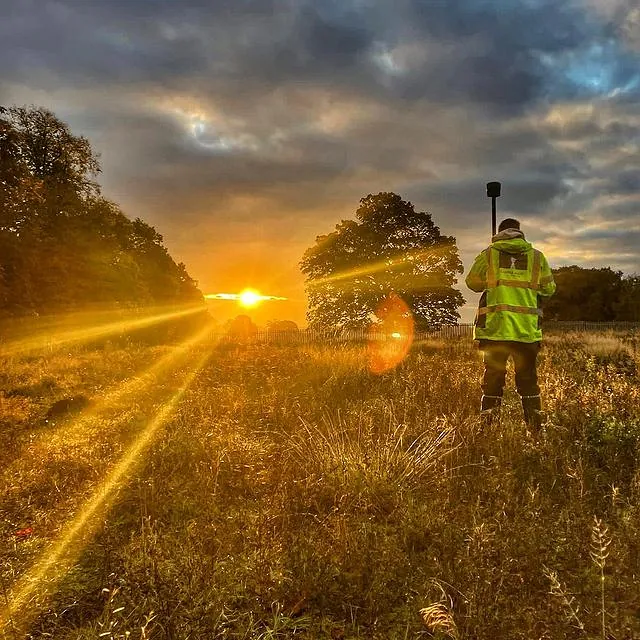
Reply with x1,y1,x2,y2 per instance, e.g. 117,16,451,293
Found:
368,293,414,374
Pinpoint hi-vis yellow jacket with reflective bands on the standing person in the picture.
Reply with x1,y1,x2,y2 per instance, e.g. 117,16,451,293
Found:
465,229,556,342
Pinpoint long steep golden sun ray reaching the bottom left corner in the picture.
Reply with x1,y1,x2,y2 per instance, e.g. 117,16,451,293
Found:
0,332,215,634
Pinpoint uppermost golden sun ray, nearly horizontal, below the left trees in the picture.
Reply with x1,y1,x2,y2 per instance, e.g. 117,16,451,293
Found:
0,305,205,356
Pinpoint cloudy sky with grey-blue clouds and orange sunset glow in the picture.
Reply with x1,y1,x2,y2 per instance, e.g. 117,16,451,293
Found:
0,0,640,323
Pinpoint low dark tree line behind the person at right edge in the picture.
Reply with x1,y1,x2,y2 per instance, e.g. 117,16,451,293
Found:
544,265,640,322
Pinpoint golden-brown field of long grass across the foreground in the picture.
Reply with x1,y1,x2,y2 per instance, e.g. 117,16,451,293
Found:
0,334,640,640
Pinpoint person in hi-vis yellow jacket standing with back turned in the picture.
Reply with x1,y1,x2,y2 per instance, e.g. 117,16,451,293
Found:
465,218,556,431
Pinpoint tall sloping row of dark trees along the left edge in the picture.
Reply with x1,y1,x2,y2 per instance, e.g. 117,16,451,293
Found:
0,107,202,315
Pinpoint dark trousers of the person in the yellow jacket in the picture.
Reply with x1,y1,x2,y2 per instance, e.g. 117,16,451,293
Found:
480,340,542,430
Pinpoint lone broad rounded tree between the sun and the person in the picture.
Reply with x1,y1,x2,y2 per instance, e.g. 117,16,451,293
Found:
300,193,464,330
